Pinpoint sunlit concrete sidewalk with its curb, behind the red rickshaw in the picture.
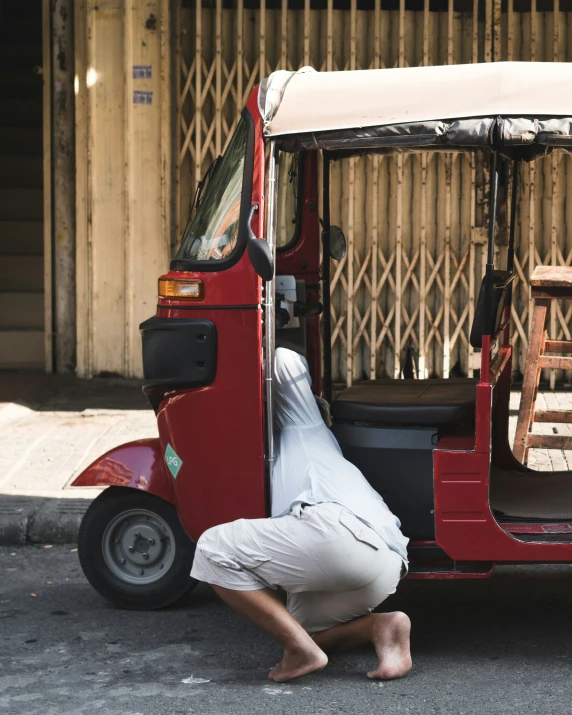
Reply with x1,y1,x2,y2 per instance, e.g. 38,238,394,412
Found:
0,373,572,545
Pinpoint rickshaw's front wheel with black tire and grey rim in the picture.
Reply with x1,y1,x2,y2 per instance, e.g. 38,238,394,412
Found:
78,487,197,610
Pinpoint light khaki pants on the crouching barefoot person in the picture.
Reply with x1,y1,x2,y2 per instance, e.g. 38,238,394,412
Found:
191,503,404,633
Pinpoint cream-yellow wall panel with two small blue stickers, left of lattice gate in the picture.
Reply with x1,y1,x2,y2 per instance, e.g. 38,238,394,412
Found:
74,0,172,377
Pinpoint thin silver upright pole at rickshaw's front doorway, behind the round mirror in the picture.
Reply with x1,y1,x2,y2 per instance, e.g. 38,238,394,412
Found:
264,141,279,496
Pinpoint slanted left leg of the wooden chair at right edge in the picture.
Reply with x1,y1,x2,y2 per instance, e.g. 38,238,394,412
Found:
513,299,550,464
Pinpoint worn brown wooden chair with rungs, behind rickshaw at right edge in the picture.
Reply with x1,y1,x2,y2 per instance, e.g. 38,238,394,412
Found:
513,266,572,464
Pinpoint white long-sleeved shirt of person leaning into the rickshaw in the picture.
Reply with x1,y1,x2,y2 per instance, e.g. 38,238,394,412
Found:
272,348,409,559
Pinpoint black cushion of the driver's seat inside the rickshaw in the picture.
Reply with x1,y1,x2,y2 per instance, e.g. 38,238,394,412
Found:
332,378,477,427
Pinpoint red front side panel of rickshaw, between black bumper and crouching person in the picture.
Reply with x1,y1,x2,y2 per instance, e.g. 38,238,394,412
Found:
158,309,266,540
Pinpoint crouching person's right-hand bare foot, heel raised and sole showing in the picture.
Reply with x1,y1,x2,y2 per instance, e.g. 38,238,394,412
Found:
367,611,412,680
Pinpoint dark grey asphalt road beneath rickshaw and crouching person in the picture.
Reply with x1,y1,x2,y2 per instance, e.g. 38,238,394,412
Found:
0,546,572,715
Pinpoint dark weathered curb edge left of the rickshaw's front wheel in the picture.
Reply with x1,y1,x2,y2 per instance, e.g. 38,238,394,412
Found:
0,495,92,546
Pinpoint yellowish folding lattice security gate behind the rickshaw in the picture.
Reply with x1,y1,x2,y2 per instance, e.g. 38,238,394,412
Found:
175,0,572,384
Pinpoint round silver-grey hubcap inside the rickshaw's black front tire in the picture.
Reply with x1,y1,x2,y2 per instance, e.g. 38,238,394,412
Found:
102,509,175,586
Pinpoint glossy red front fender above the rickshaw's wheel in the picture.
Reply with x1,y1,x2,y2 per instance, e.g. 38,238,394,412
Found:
72,437,175,504
